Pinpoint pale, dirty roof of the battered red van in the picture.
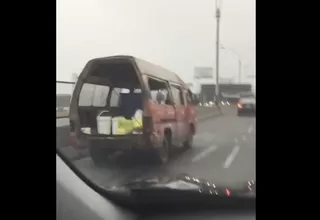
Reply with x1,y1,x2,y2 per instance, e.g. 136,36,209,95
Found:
90,55,189,89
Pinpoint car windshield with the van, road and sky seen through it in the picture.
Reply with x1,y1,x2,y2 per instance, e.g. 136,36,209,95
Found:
56,0,256,199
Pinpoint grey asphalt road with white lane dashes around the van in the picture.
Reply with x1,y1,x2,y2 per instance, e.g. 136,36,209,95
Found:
70,109,256,187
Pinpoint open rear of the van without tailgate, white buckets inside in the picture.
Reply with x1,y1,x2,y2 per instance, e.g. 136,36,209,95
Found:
77,59,145,136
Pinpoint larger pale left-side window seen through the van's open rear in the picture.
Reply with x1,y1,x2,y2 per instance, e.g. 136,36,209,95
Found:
79,83,110,107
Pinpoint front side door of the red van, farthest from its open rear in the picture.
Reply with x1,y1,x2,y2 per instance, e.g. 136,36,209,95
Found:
171,84,189,146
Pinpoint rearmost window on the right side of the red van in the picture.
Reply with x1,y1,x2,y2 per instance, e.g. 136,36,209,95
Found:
148,78,172,105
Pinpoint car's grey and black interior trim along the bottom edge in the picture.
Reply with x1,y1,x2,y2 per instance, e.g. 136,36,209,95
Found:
56,155,255,220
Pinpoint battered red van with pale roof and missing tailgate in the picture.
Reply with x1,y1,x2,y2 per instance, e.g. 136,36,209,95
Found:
69,56,197,164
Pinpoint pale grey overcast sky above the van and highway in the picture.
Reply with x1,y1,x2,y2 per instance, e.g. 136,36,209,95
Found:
57,0,255,87
